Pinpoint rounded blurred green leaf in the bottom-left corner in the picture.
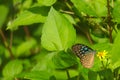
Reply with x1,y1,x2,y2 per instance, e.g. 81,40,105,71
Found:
3,60,23,78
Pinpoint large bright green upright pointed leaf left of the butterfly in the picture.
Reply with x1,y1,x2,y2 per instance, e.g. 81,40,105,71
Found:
41,7,76,51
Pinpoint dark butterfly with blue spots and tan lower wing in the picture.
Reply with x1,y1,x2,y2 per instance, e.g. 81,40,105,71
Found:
72,44,96,68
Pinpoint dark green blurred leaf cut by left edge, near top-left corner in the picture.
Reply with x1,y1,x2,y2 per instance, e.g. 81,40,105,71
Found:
0,5,8,28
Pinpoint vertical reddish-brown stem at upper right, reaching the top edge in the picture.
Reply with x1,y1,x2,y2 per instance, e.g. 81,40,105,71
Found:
107,0,113,43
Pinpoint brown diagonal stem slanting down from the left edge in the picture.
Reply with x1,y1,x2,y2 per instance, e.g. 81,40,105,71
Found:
0,29,14,59
